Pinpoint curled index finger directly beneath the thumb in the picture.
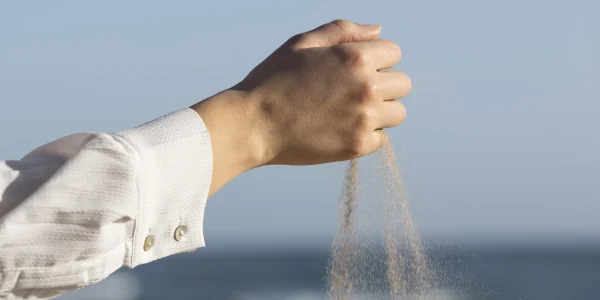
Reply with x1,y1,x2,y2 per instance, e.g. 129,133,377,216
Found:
348,39,402,70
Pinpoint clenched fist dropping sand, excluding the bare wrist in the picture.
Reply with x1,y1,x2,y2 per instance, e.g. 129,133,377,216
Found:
235,20,410,165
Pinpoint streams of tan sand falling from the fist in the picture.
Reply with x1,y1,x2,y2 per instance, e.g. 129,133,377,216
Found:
328,131,434,300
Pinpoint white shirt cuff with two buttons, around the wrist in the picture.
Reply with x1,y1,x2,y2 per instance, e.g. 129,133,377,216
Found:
117,108,213,267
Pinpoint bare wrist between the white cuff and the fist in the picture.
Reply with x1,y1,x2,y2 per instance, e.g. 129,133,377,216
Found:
191,90,268,194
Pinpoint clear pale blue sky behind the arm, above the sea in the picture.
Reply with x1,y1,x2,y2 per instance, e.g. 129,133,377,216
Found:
0,0,600,247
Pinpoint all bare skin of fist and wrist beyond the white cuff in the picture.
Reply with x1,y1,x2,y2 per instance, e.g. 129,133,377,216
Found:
191,20,411,195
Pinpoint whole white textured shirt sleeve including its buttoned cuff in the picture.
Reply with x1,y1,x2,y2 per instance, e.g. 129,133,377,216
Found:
0,109,213,299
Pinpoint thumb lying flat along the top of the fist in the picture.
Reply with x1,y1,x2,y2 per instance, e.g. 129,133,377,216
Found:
296,20,381,48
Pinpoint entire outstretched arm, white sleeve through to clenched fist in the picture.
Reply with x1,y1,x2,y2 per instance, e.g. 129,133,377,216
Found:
0,21,410,299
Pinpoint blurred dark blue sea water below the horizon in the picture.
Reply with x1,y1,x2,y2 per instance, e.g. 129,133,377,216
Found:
57,248,600,300
